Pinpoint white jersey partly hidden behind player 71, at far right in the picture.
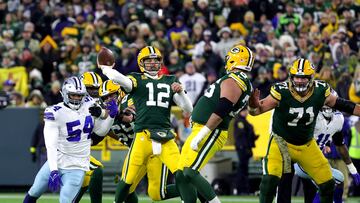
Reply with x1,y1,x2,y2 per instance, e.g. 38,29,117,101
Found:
314,111,344,149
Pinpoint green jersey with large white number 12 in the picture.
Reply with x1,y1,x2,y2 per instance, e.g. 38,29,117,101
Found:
128,73,178,132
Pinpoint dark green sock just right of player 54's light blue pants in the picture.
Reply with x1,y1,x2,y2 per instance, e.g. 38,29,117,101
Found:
89,167,103,203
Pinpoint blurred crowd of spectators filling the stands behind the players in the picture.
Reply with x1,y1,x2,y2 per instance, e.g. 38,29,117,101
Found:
0,0,360,107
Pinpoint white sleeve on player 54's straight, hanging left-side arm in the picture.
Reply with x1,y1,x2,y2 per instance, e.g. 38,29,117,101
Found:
44,121,59,171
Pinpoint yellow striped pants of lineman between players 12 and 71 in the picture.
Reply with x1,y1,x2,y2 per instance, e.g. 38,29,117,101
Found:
178,123,228,171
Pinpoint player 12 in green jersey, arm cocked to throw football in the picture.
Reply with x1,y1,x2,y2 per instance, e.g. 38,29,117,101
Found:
98,46,192,202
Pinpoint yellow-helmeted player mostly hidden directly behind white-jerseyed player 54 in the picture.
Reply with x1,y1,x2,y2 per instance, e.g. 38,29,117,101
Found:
74,72,105,203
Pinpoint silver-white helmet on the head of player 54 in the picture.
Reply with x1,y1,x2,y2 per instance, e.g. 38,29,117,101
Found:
61,76,86,110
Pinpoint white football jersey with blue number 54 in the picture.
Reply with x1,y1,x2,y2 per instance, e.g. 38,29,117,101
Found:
44,98,95,171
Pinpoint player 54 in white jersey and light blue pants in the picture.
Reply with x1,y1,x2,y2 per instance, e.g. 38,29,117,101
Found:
24,77,117,203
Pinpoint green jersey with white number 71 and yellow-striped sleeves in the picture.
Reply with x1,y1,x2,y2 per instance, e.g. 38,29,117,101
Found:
270,80,330,145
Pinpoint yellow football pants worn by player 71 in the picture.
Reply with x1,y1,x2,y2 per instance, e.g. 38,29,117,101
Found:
263,135,332,185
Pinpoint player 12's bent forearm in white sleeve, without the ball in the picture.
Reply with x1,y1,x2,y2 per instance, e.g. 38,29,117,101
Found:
171,82,193,113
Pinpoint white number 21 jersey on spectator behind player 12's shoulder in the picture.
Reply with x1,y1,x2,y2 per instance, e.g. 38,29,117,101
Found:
179,73,206,104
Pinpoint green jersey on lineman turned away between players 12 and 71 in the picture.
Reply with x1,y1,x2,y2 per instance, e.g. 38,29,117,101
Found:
191,72,253,130
